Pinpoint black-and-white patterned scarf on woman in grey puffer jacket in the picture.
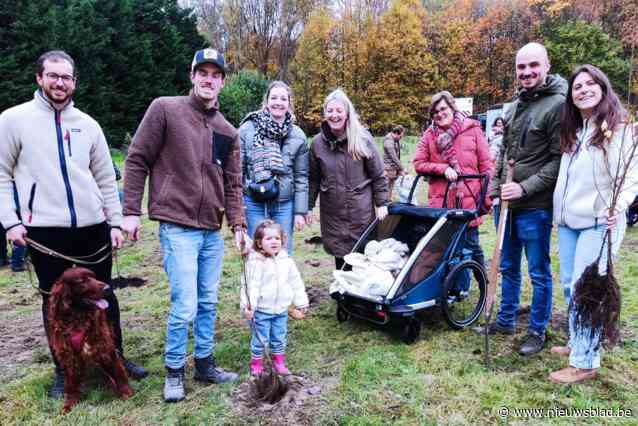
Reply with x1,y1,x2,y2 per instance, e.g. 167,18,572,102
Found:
243,110,292,182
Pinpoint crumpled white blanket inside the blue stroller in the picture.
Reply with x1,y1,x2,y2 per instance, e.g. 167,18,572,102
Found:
330,238,409,298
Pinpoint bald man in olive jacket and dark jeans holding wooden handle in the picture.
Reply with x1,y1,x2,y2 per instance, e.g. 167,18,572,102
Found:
488,43,567,355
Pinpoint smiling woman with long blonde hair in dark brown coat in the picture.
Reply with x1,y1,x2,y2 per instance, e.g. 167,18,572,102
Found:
306,89,389,269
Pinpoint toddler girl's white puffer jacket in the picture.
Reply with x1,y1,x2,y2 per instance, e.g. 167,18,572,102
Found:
241,250,308,315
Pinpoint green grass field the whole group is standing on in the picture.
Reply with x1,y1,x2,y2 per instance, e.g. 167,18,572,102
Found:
0,139,638,425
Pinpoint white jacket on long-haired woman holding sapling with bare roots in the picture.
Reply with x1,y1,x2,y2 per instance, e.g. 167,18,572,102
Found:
554,120,638,229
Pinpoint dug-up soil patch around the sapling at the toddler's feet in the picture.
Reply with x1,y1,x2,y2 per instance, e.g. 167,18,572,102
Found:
233,375,336,425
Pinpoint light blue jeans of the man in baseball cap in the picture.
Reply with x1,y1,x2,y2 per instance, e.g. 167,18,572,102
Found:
159,222,224,369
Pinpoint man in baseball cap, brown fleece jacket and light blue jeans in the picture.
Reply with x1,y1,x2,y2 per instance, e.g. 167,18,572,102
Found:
122,49,246,402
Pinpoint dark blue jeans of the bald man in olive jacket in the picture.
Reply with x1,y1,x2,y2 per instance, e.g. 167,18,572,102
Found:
496,209,552,336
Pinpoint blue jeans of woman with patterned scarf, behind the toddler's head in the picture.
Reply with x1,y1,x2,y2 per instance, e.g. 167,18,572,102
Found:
244,195,295,254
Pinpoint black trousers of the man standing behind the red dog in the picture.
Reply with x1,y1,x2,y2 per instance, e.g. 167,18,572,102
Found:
27,222,124,366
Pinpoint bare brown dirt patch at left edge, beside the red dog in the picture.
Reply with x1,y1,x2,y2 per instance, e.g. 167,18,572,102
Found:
0,314,48,382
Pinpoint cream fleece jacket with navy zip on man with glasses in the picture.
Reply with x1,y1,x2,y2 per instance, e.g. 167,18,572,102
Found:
0,90,122,229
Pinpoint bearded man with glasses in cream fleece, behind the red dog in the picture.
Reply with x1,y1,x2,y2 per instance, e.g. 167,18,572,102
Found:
0,51,147,398
